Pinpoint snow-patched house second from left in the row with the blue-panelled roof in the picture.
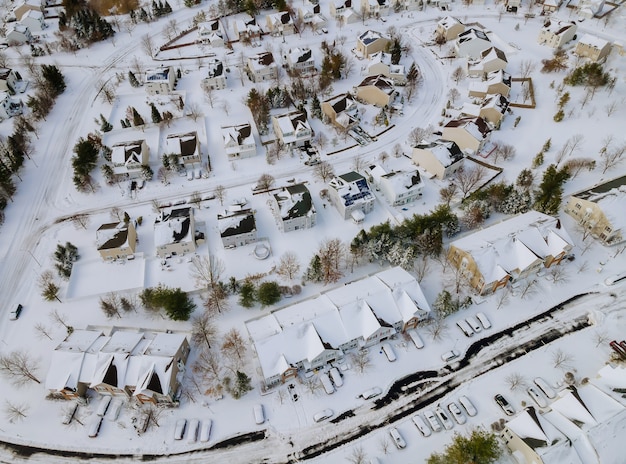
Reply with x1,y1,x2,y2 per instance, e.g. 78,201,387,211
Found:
154,207,196,258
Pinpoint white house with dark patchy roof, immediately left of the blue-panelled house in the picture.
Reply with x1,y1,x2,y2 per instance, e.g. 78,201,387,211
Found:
270,184,316,232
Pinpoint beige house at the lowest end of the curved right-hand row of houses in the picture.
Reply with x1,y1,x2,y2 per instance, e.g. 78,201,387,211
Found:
411,139,463,179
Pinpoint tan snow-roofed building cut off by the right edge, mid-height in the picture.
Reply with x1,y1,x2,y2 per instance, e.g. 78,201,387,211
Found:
565,176,626,245
